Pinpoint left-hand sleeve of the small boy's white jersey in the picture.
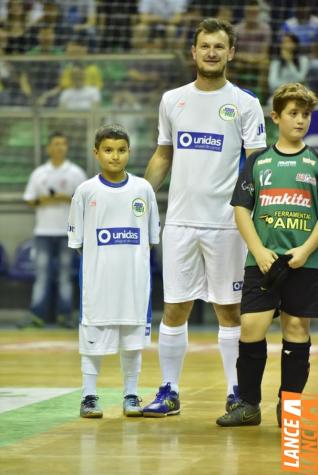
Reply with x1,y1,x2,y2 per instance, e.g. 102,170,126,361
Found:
67,191,84,249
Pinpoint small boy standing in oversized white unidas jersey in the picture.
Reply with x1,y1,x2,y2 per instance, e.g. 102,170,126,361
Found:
68,125,160,417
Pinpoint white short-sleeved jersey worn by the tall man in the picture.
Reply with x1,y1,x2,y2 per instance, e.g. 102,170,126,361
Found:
158,81,266,229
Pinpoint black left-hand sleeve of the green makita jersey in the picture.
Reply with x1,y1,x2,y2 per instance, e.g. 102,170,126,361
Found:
231,152,260,210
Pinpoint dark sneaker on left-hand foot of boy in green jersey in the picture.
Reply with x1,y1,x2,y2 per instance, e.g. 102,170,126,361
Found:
216,401,261,427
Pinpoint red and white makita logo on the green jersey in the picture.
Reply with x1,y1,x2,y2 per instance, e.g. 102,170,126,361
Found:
259,188,312,208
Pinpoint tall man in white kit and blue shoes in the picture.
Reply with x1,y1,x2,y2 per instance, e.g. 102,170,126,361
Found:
143,18,266,417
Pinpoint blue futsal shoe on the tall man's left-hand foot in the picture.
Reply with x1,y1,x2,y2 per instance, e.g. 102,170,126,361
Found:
143,383,180,417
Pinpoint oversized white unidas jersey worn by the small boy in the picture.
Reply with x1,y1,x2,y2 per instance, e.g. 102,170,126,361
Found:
68,174,160,326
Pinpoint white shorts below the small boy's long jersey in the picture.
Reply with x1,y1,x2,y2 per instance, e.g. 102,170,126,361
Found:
79,325,150,355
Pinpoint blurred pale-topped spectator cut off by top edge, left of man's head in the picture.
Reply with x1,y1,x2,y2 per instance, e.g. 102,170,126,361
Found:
132,0,189,51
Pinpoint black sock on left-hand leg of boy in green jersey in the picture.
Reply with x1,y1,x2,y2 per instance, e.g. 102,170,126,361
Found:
236,338,267,405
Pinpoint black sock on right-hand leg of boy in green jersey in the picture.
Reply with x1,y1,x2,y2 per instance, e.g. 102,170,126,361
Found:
278,339,311,398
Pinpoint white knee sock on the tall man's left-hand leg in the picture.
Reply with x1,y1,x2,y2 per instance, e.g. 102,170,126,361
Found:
159,322,188,392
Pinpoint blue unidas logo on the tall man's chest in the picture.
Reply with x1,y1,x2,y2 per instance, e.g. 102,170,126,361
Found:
177,132,224,152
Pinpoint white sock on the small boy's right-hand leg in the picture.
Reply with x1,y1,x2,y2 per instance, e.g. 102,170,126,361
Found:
120,350,141,397
